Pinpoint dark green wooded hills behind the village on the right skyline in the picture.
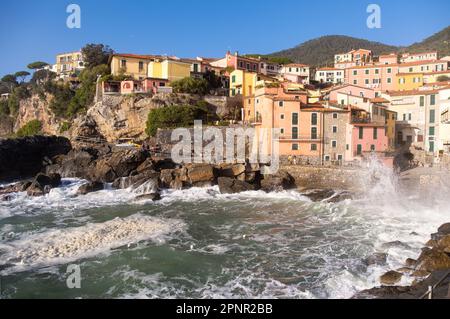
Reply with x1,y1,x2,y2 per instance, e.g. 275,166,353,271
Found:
269,26,450,67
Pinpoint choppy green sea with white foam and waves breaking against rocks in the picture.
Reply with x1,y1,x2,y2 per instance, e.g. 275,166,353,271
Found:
0,172,449,298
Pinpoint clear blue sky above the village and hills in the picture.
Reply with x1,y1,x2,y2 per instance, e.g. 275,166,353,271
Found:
0,0,450,76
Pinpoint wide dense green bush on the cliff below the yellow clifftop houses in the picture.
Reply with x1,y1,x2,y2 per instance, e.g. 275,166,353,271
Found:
145,105,208,136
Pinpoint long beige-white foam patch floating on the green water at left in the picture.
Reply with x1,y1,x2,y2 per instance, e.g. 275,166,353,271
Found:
0,214,184,272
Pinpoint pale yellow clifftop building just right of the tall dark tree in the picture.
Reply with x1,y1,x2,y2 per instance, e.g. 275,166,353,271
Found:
109,54,157,80
